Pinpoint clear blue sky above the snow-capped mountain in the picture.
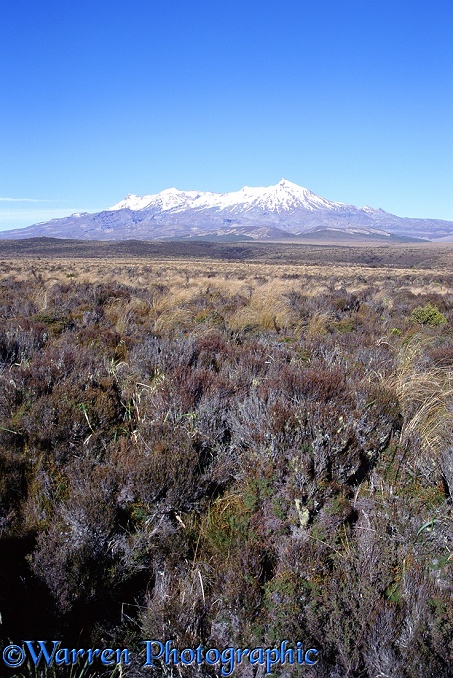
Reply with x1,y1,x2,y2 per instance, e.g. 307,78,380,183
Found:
0,0,453,229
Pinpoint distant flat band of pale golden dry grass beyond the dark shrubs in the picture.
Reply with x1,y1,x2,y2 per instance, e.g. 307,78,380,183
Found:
0,258,451,308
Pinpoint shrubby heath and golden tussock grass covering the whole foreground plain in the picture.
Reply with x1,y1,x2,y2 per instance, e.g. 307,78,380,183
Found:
0,246,453,678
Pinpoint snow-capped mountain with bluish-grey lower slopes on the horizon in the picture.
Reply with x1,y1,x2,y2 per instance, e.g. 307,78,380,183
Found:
1,179,453,241
